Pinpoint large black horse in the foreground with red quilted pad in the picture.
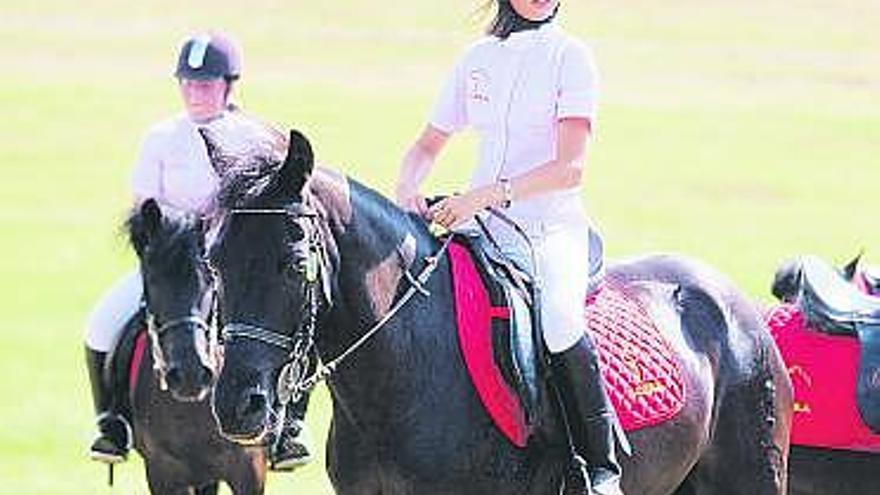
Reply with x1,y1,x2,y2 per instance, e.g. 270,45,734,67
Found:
208,131,791,495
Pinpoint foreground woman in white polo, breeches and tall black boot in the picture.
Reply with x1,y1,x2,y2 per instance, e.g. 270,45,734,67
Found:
396,0,622,495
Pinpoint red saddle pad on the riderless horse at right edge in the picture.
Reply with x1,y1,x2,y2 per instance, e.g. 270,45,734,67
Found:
766,304,880,452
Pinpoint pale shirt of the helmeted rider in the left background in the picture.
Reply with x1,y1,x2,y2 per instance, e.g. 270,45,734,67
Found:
131,111,266,213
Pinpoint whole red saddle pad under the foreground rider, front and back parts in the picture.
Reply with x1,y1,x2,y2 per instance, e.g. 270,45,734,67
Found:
449,243,685,447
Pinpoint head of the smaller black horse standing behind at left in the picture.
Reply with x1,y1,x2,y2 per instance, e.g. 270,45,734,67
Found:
127,199,216,401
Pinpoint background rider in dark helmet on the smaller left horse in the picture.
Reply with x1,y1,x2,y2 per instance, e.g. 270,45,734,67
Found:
85,33,311,470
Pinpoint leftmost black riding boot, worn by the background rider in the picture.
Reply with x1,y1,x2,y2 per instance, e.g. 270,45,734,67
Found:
86,346,131,464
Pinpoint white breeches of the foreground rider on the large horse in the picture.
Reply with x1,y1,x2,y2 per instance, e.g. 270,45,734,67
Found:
482,220,590,353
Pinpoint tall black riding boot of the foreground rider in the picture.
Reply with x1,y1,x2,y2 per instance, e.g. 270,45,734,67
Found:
552,337,623,495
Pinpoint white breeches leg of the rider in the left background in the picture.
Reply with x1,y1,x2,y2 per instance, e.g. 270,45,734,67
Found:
86,270,143,352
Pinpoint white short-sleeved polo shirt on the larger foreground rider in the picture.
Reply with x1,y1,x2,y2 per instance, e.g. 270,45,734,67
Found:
430,22,598,229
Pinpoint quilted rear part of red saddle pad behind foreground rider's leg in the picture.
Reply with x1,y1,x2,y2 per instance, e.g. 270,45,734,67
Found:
586,282,685,431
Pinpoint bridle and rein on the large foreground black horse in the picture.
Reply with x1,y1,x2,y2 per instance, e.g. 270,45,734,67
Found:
222,204,453,407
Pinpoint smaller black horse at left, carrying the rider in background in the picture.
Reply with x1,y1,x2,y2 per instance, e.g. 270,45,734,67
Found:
127,200,266,495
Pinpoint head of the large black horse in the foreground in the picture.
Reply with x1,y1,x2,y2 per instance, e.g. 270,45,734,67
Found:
206,131,327,443
